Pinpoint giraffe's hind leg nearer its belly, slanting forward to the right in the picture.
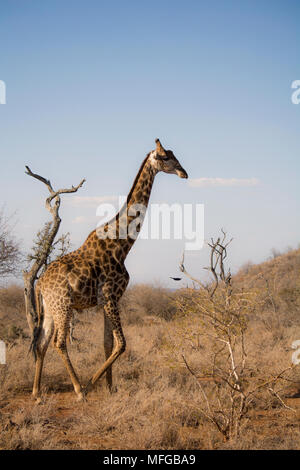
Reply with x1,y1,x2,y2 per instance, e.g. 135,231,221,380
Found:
54,307,84,401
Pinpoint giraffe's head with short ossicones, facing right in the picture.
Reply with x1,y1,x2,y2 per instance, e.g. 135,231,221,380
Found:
149,139,188,178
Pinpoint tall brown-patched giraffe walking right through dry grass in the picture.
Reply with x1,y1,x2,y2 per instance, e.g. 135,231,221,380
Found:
31,139,188,401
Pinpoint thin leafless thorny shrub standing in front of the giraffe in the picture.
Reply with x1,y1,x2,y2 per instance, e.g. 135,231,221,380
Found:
177,230,294,440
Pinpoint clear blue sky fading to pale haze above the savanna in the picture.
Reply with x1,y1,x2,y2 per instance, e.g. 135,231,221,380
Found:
0,0,300,286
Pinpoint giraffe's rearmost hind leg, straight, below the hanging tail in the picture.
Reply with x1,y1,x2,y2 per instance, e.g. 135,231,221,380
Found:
32,311,54,398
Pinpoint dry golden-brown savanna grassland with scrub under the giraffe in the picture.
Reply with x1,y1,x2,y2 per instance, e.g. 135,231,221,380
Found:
0,250,300,450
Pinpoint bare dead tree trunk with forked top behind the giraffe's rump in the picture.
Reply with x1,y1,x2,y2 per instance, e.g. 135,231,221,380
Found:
23,166,85,333
